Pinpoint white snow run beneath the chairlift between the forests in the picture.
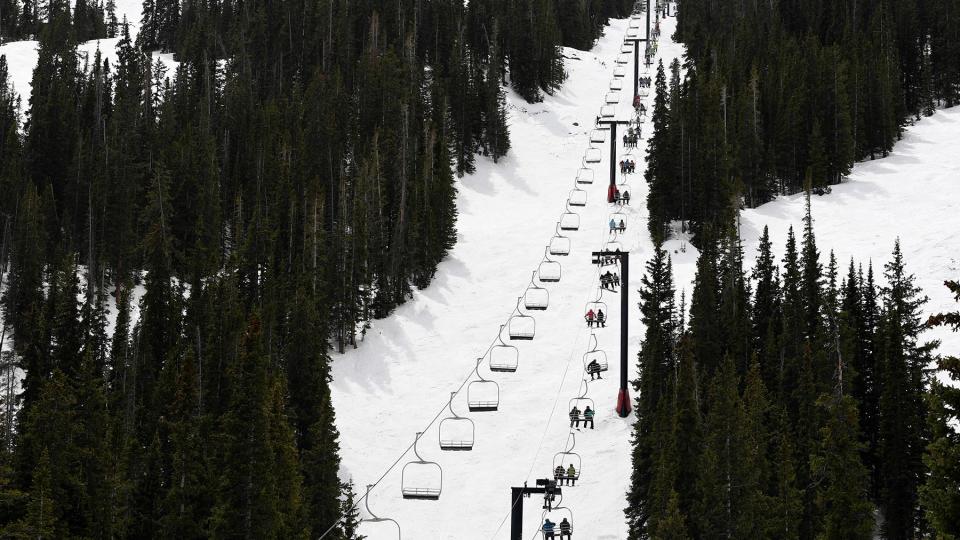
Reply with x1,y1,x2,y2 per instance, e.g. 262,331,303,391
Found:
333,11,681,540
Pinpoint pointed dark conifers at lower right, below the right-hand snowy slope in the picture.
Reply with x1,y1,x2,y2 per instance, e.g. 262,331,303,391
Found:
626,199,960,539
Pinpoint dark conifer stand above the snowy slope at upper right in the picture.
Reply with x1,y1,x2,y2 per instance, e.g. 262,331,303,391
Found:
646,0,960,243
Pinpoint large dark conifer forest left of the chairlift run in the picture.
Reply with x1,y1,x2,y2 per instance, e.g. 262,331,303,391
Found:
0,0,632,538
